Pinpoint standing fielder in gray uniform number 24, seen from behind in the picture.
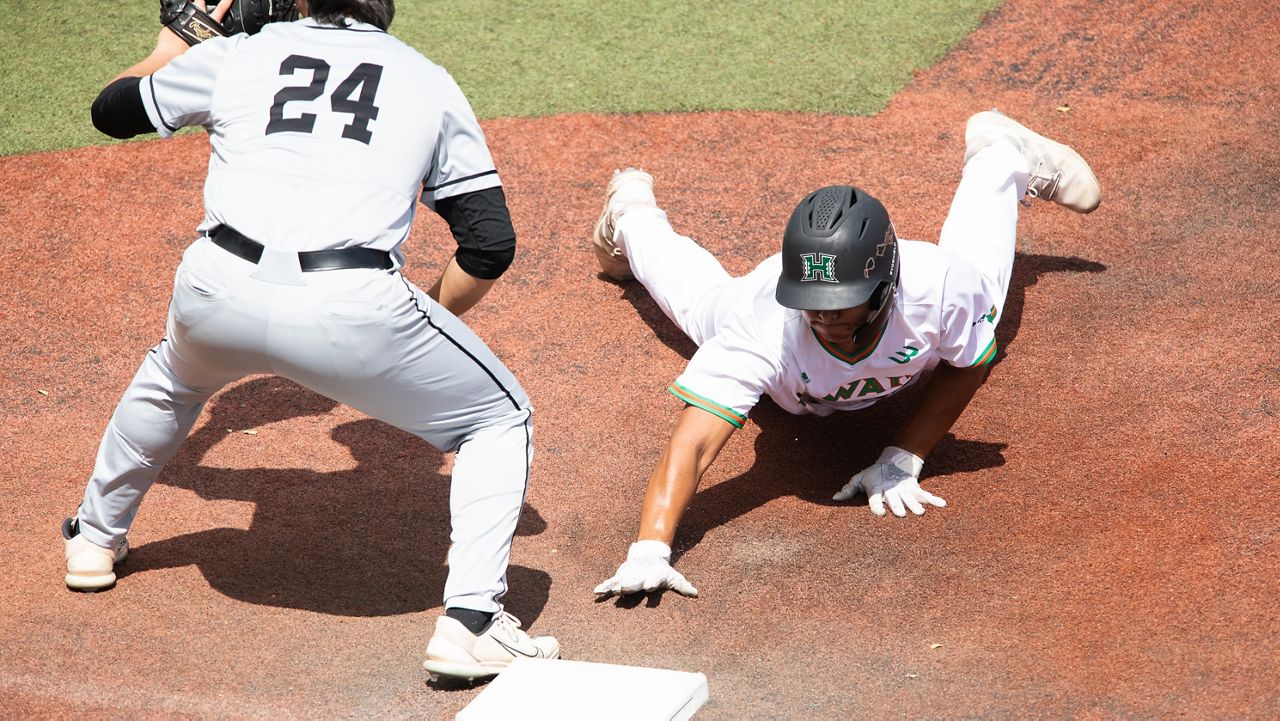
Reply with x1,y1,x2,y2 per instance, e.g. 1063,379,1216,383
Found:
63,0,559,677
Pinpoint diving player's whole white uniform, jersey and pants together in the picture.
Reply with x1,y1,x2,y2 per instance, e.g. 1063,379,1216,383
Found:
613,138,1028,428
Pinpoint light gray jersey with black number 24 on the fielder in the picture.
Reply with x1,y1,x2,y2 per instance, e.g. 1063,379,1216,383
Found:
141,19,500,266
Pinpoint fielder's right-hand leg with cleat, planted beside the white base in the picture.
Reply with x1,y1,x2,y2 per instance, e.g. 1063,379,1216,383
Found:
262,270,559,676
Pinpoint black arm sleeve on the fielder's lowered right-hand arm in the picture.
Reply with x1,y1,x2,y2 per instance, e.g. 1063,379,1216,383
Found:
435,187,516,280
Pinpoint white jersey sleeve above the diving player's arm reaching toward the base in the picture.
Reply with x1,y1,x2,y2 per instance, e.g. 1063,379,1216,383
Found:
667,316,782,428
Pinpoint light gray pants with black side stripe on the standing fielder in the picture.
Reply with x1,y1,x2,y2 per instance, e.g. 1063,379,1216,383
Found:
78,238,532,612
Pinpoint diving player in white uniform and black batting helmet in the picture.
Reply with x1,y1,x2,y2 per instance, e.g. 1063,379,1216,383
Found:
593,111,1101,595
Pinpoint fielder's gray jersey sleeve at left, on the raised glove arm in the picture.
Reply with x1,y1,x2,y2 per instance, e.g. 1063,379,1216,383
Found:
138,36,243,138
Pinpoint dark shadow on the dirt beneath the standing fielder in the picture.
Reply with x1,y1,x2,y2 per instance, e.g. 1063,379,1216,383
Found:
122,378,550,628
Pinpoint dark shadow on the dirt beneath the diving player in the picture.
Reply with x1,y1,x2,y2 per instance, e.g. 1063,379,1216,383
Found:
606,254,1106,566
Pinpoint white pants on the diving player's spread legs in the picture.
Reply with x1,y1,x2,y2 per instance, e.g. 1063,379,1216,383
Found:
613,142,1029,346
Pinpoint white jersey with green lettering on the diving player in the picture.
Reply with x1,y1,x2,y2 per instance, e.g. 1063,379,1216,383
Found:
669,241,997,428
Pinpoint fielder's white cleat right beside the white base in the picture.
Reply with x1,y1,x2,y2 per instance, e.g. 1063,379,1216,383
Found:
422,611,559,679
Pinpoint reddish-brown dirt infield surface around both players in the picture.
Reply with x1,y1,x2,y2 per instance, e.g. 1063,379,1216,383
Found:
0,0,1280,718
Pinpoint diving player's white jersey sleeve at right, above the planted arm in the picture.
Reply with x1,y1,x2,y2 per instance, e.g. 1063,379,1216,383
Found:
938,259,1000,368
